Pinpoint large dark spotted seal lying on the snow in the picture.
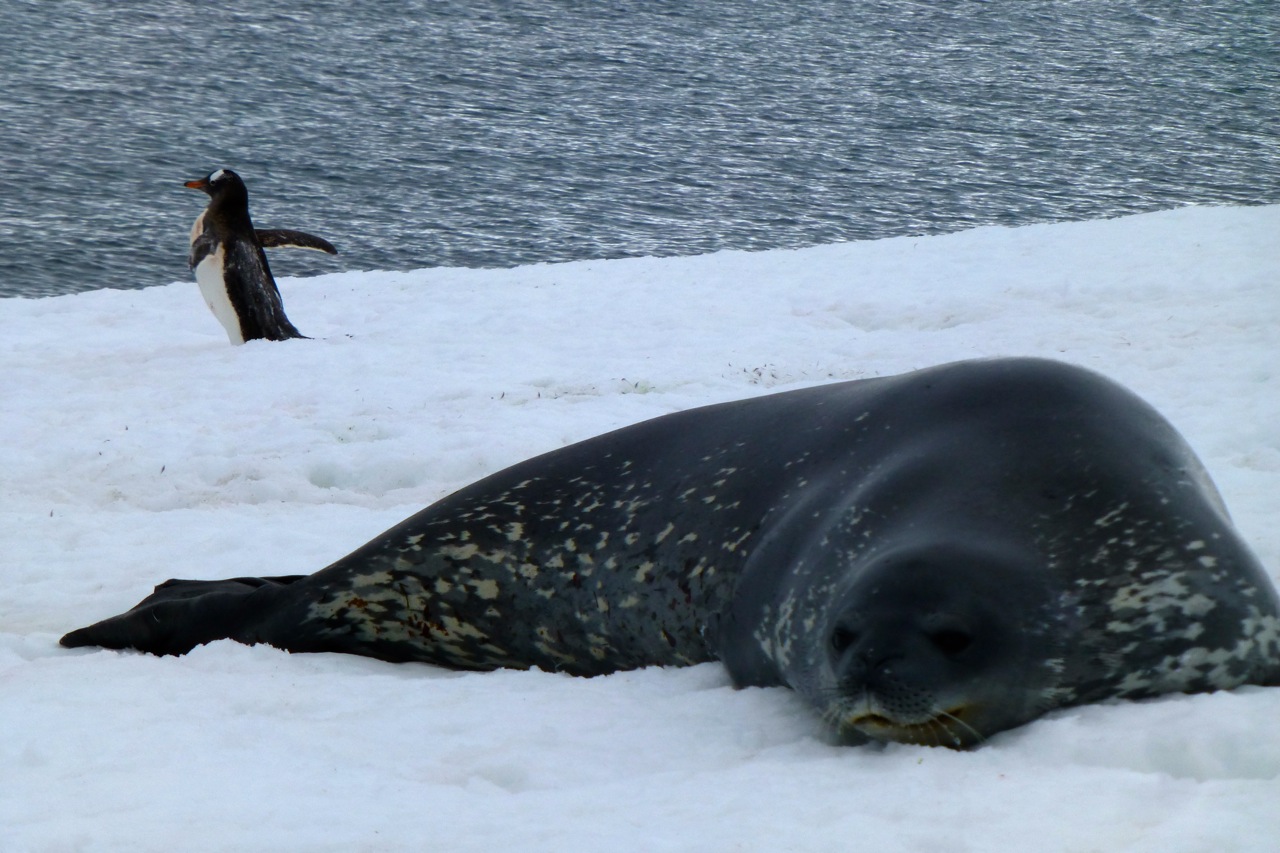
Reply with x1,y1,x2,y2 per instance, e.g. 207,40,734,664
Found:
61,359,1280,747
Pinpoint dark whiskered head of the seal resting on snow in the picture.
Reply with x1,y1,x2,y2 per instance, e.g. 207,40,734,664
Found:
796,543,1064,748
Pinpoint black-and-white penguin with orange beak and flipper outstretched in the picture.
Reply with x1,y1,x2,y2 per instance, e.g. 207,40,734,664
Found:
183,169,338,343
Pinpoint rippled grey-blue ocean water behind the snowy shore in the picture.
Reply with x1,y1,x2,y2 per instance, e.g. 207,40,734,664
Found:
0,0,1280,296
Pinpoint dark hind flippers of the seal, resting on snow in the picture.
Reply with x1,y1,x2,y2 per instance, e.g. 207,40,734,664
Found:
60,575,305,654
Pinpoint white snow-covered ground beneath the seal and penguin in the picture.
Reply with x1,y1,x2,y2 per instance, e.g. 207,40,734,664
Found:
0,206,1280,853
